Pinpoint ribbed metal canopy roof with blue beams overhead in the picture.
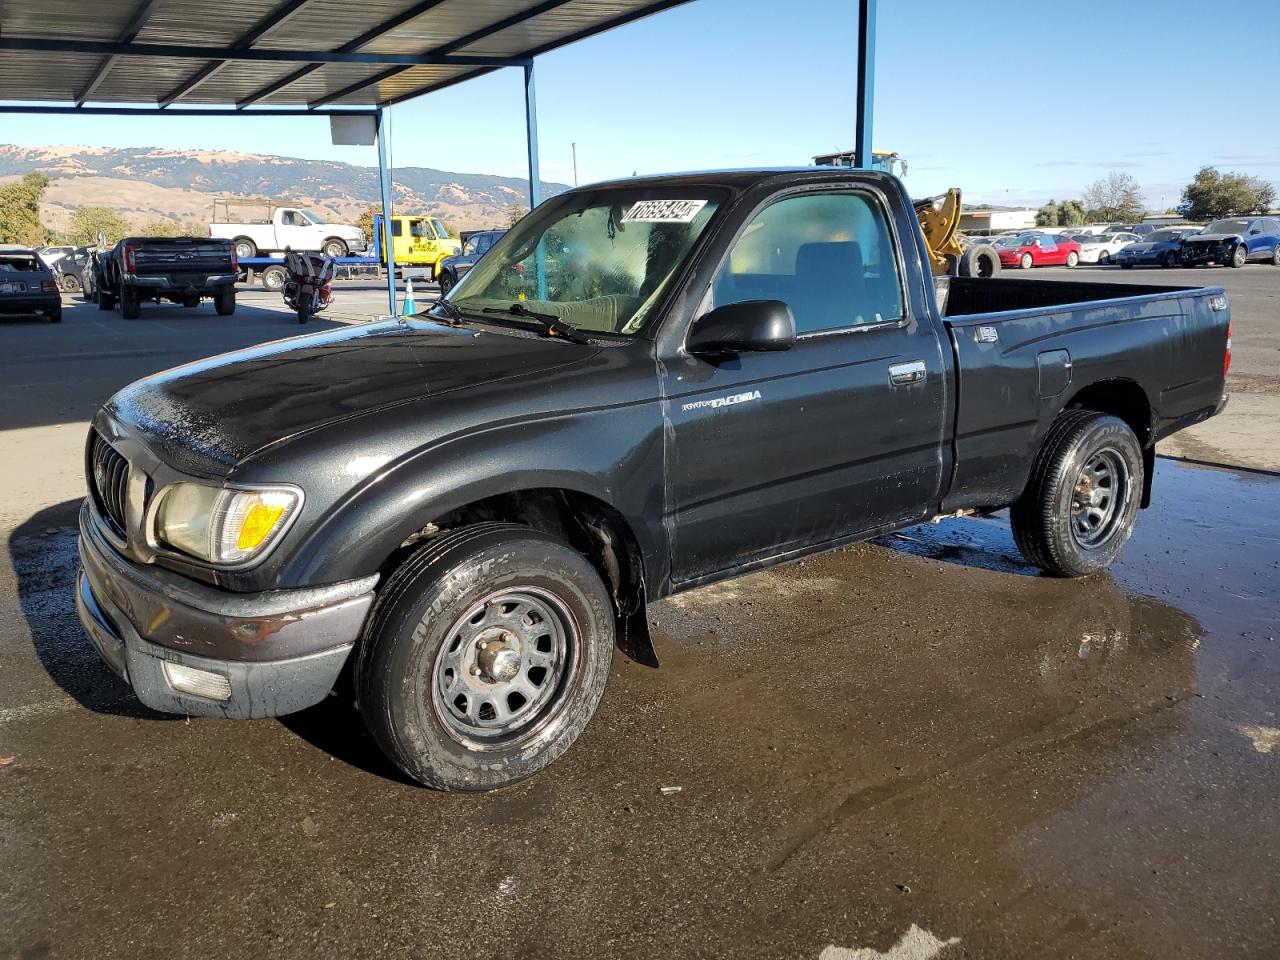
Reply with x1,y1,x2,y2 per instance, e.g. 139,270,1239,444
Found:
0,0,687,113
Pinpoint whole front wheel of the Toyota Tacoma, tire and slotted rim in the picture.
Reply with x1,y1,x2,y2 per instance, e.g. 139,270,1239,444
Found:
355,524,614,792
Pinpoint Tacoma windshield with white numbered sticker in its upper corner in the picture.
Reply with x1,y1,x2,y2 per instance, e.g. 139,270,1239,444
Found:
447,189,719,334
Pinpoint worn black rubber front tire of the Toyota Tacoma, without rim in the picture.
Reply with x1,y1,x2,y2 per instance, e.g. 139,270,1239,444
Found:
353,524,614,792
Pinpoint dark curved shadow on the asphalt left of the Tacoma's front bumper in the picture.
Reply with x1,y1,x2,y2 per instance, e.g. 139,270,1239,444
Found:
9,499,178,719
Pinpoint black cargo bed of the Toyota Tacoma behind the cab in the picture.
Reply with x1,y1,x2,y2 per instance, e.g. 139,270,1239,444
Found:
938,276,1229,511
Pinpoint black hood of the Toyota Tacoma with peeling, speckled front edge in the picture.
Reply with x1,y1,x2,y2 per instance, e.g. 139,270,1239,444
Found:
105,320,598,476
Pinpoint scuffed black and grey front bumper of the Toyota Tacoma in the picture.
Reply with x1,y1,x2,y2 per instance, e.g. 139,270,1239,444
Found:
76,502,378,719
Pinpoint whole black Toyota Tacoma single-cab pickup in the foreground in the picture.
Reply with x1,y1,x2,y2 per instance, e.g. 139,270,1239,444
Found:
77,168,1230,790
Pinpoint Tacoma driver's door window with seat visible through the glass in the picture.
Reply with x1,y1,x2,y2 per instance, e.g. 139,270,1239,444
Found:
712,192,905,334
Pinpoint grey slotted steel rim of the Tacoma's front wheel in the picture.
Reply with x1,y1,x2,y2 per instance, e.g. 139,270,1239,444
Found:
431,586,581,750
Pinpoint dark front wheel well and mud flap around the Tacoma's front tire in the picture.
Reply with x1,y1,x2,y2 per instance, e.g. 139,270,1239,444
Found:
381,489,658,667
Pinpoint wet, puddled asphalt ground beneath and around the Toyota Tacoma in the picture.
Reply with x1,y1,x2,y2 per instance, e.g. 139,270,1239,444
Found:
0,281,1280,960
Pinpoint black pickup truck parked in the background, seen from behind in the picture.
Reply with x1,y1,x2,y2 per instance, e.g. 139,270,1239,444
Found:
93,237,239,320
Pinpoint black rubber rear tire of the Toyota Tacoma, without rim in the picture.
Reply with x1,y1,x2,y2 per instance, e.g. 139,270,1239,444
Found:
1009,410,1143,577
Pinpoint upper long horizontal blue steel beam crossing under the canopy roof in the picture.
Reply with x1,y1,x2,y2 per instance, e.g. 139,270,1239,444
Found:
0,37,527,69
